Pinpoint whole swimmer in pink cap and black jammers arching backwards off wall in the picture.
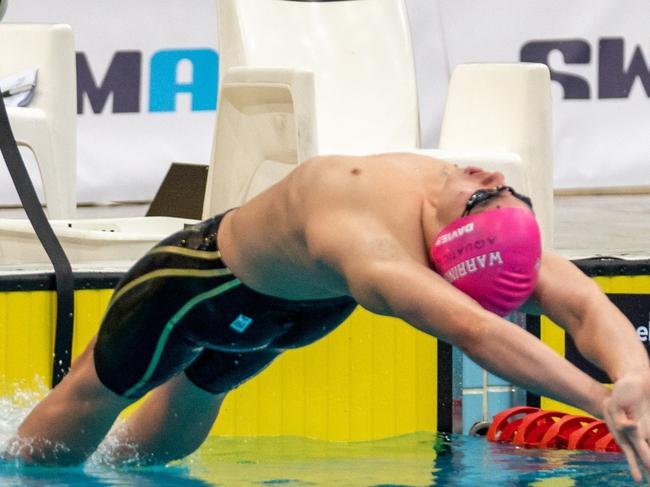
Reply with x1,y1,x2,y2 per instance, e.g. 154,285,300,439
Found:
8,154,650,480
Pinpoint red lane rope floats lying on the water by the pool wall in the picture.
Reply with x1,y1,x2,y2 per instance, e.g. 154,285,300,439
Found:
487,406,621,452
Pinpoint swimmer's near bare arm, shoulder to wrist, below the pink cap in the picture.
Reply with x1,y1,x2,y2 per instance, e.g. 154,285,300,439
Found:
312,229,608,415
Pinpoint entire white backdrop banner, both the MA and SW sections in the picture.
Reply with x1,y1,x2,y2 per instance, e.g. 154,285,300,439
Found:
0,0,650,204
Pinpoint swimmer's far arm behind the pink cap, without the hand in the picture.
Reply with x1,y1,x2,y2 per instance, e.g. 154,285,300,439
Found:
533,254,650,382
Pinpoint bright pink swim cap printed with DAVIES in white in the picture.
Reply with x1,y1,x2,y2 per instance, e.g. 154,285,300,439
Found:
431,208,542,316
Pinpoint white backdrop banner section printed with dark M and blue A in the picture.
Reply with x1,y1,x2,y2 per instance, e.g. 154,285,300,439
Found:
0,0,218,204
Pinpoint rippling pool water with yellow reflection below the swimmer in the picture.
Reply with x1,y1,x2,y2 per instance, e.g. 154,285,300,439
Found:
0,393,638,487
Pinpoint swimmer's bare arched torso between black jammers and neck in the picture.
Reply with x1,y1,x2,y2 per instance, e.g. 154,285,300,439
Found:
219,154,452,299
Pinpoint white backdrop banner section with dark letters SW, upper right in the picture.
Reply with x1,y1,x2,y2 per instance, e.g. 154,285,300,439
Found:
426,0,650,191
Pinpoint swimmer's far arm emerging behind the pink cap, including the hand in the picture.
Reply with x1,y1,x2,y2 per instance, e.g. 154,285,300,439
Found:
534,254,650,482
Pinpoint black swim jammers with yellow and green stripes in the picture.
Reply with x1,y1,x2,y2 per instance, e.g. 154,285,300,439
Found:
95,215,356,398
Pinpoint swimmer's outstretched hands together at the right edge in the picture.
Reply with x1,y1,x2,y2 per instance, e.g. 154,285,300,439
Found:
603,374,650,482
